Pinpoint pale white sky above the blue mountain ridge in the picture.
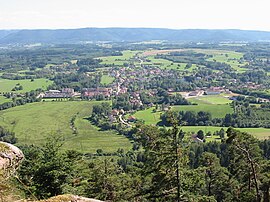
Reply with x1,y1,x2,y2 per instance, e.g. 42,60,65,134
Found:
0,0,270,31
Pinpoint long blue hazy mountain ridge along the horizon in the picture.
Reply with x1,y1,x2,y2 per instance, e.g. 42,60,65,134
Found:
0,28,270,44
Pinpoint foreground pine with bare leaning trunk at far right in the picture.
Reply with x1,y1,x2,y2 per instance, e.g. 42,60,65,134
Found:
226,127,262,202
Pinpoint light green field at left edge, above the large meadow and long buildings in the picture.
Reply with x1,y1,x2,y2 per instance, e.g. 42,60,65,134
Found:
0,79,53,93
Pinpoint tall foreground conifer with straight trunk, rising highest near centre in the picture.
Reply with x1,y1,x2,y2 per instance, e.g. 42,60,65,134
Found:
135,119,188,201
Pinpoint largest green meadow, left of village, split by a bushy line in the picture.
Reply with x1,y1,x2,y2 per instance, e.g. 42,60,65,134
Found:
0,101,131,152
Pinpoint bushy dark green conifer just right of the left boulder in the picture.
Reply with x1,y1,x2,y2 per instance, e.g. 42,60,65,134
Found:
19,136,72,199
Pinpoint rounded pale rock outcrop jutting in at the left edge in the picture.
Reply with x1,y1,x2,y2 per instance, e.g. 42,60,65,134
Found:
0,142,24,177
